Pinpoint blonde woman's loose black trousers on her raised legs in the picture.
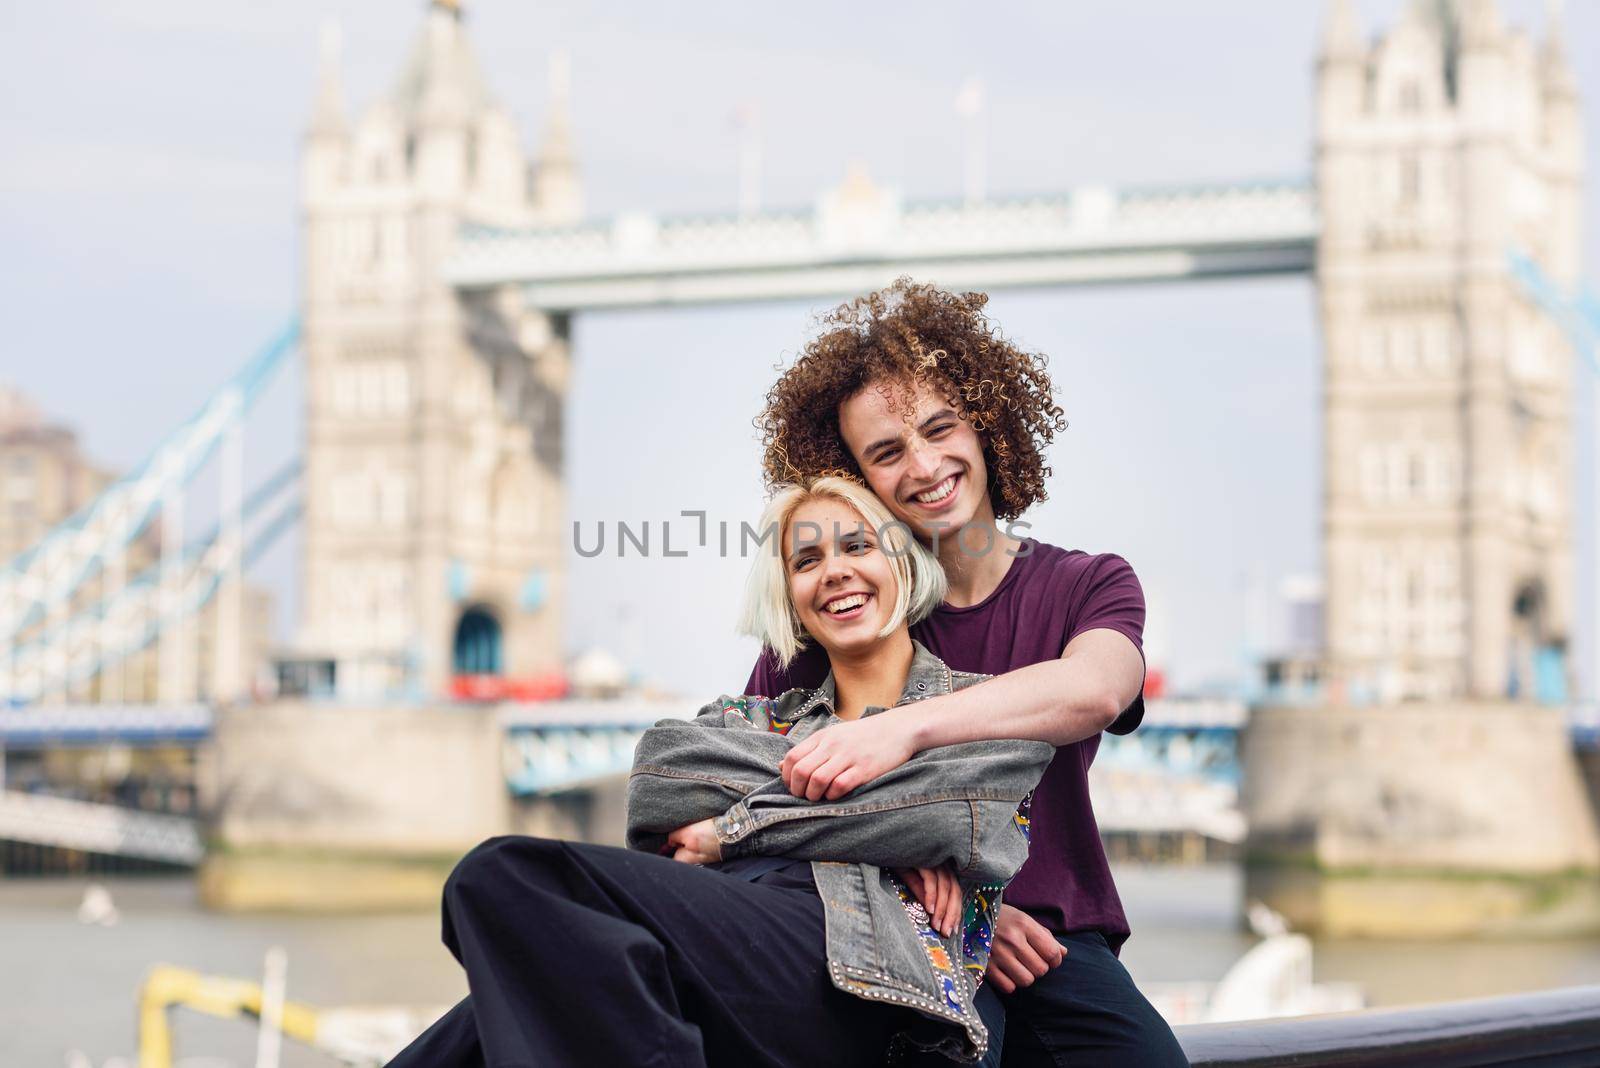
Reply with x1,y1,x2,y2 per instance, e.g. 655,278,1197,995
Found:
389,838,915,1068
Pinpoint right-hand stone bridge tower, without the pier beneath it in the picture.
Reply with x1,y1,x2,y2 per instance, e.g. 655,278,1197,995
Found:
1317,0,1582,703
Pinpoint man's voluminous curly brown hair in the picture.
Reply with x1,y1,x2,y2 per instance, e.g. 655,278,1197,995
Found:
755,278,1067,520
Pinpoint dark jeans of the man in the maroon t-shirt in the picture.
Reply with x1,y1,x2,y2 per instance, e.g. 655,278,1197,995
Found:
904,931,1189,1068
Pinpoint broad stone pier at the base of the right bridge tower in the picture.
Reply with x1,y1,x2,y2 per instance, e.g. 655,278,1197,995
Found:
1240,702,1600,937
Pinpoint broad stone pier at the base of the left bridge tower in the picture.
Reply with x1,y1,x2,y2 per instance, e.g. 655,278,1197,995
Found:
198,702,627,911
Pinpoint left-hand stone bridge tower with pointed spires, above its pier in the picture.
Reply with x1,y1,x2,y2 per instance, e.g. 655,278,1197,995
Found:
299,0,582,697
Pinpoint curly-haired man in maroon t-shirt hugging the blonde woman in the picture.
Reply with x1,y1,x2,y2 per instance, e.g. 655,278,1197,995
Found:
746,280,1187,1066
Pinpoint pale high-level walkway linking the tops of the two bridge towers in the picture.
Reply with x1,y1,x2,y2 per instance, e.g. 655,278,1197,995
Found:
445,176,1318,312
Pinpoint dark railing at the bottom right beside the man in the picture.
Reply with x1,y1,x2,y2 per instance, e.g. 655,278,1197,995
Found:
1178,986,1600,1068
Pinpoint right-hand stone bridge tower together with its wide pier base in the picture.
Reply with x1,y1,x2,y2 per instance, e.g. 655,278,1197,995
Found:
1240,0,1600,937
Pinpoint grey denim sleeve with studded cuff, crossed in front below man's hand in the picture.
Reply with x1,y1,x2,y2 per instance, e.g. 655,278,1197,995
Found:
715,740,1054,884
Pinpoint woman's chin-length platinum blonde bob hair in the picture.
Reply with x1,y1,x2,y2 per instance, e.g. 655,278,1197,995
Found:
739,475,946,668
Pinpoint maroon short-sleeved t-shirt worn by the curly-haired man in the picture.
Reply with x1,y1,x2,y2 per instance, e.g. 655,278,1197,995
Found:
744,539,1144,950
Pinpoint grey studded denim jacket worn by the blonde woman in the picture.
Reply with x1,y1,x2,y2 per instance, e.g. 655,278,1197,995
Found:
627,643,1054,1060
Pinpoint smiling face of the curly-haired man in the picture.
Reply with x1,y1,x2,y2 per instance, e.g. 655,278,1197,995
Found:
838,381,995,540
